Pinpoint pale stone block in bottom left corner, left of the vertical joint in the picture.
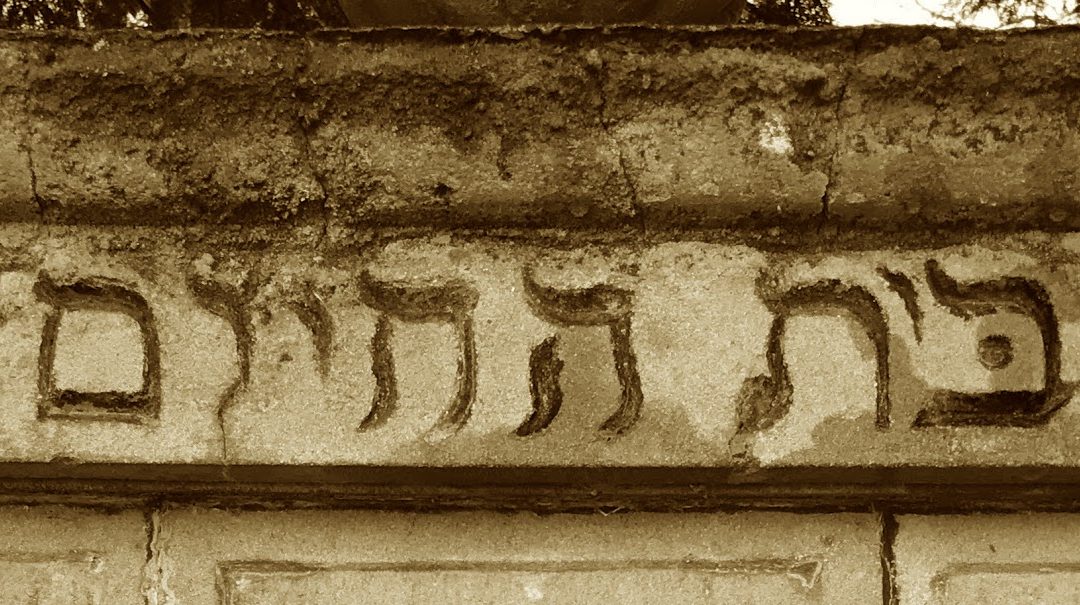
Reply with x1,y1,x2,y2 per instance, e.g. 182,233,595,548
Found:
0,507,147,605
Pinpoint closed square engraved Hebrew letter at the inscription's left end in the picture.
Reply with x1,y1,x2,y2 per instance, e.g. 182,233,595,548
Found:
33,273,161,421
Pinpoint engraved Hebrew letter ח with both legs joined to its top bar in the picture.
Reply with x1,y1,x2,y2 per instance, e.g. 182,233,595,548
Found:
360,271,480,435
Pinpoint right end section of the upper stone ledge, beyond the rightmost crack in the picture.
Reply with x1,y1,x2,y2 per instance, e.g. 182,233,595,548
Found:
829,25,1080,229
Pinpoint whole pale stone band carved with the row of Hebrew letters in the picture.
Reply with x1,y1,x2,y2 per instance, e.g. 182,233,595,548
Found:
0,229,1080,466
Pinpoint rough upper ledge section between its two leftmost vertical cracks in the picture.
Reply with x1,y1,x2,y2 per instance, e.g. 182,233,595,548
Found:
23,36,323,224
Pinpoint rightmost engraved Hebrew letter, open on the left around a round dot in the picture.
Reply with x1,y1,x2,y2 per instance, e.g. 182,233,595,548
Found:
914,259,1076,427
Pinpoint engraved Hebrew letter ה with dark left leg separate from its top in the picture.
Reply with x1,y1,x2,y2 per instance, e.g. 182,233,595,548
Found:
516,269,644,436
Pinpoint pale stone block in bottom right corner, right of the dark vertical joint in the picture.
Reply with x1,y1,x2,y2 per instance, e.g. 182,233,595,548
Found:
895,514,1080,605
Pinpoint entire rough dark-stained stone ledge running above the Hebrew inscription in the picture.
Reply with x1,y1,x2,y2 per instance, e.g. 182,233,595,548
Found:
0,27,1080,229
